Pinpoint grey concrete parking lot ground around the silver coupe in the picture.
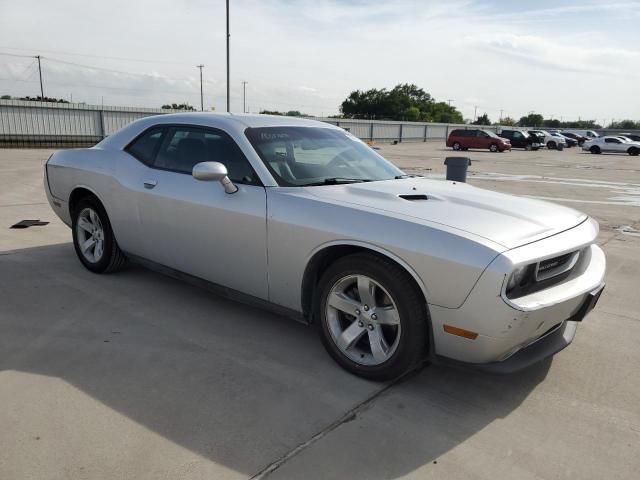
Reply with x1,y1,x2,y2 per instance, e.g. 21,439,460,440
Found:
0,142,640,480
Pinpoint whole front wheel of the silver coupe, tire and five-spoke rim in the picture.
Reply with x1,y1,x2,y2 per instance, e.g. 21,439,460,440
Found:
316,254,428,381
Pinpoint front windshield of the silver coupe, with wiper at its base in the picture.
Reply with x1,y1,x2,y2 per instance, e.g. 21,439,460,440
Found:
245,127,404,187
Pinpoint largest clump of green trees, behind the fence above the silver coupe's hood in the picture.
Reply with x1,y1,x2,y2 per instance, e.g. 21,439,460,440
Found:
340,83,462,123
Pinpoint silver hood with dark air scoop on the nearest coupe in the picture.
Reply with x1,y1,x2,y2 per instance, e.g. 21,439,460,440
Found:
305,178,587,249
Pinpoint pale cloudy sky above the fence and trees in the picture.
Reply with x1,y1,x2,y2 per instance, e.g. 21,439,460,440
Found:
0,0,640,123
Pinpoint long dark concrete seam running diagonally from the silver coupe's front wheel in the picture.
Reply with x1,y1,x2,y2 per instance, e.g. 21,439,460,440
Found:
249,368,421,480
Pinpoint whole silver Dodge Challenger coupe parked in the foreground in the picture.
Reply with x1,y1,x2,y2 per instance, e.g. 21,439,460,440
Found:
44,113,605,380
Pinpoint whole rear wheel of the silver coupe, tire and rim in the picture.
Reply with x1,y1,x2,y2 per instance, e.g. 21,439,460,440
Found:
72,197,126,273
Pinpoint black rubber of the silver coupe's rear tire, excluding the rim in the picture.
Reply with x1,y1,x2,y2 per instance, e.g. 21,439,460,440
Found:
71,196,127,273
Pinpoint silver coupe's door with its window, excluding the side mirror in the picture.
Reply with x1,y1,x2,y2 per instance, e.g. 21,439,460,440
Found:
138,126,268,299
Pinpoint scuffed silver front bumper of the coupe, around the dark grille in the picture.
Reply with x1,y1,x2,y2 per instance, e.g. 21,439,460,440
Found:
429,221,606,364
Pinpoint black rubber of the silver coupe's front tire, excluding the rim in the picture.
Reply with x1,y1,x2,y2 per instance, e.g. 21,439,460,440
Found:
315,253,429,381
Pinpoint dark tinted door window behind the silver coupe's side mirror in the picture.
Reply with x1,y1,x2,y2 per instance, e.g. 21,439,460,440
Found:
153,127,259,185
